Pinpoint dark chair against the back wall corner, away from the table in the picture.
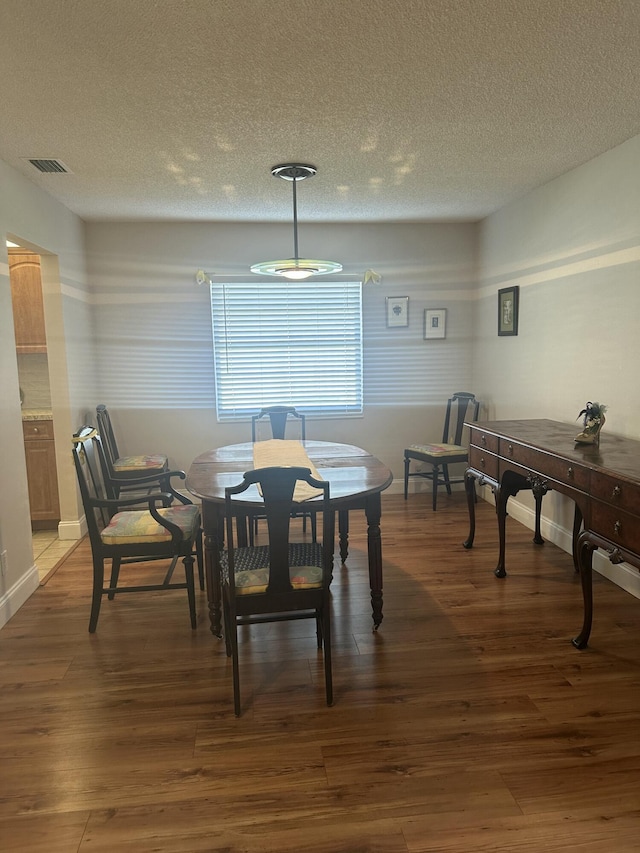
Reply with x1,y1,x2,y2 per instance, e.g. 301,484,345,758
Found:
404,391,480,512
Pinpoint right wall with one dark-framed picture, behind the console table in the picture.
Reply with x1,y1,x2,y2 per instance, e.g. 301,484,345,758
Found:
473,137,640,593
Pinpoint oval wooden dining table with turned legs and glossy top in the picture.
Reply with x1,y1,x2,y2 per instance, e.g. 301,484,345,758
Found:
186,440,393,636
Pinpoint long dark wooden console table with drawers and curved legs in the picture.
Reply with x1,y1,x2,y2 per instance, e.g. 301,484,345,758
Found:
464,419,640,649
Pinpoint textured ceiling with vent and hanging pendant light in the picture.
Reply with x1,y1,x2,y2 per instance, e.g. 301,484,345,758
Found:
0,0,640,222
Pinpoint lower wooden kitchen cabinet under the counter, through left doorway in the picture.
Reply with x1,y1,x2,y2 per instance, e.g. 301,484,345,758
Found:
22,420,60,530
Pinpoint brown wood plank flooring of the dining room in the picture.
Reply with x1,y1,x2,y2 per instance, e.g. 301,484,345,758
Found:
0,494,640,853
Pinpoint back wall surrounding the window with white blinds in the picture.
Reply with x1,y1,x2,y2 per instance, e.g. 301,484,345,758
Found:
86,222,476,478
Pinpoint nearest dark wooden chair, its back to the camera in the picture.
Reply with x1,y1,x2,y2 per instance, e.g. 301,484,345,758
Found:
221,467,335,716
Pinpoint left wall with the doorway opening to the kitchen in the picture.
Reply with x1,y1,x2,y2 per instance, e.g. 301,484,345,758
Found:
0,161,95,626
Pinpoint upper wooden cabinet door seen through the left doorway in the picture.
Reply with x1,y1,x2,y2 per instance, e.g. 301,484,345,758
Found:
9,254,47,352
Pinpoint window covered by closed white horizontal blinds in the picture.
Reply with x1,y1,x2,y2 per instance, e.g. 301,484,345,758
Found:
211,281,362,421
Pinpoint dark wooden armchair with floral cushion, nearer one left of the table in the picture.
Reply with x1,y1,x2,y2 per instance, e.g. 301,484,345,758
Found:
73,426,202,633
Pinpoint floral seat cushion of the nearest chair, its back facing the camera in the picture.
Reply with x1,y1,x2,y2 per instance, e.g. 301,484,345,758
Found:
221,542,322,595
